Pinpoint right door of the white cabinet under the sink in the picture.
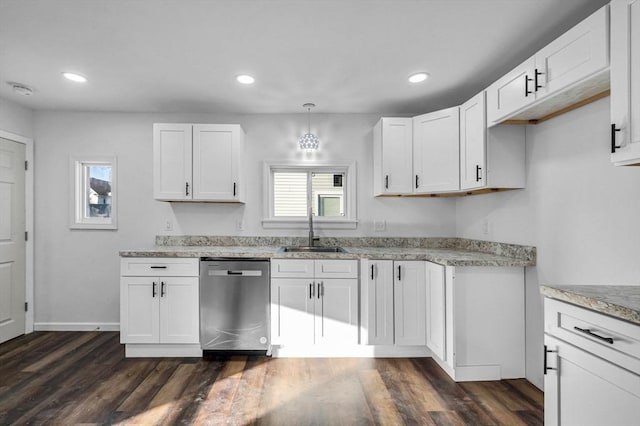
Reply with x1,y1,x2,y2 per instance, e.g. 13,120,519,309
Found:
315,278,358,345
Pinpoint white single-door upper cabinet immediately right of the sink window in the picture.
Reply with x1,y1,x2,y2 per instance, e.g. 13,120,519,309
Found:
373,117,413,195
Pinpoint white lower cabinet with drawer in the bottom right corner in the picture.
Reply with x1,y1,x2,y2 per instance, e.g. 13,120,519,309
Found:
544,298,640,426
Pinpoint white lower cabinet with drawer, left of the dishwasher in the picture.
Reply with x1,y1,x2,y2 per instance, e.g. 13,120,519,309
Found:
120,258,201,356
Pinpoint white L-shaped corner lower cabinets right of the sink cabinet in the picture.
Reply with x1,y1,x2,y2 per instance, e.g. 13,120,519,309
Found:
361,259,525,381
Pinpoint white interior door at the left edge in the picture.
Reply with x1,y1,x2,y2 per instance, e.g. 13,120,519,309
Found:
0,138,26,343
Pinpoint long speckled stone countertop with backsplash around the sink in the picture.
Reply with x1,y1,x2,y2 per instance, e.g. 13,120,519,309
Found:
120,236,536,266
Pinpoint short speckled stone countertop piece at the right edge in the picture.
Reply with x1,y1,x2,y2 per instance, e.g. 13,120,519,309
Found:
540,285,640,325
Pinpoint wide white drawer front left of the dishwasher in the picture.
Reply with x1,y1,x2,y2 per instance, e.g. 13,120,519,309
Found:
120,257,200,277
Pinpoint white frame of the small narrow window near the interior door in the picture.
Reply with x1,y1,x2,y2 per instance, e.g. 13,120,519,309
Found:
69,156,118,229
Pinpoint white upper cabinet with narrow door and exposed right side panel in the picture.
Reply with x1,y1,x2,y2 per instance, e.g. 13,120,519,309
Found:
460,91,525,191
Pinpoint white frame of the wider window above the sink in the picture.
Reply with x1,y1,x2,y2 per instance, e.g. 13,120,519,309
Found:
262,161,358,229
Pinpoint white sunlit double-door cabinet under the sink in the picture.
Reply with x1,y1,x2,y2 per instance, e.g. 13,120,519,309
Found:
271,259,358,347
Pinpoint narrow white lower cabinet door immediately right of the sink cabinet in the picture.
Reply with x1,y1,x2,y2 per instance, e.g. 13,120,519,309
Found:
362,260,393,345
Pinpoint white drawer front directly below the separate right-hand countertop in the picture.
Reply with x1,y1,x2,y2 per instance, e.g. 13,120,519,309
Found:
544,298,640,374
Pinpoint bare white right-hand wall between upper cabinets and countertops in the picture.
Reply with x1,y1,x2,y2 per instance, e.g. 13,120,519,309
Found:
456,98,640,387
